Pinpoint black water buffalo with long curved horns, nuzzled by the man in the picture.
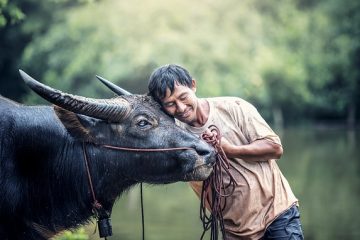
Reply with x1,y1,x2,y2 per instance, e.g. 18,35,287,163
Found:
0,72,215,240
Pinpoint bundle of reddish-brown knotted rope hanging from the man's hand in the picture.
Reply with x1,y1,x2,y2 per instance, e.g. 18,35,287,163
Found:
200,125,236,240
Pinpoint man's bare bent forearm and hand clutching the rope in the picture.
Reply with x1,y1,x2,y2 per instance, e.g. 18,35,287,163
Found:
221,138,283,161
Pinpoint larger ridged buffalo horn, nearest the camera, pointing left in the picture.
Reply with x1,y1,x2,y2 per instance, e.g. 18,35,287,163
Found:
19,70,130,122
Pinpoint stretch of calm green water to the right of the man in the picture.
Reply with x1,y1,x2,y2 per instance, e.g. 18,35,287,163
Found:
279,129,360,240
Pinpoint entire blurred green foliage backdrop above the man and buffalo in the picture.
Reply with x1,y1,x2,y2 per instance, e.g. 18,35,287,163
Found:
0,0,360,124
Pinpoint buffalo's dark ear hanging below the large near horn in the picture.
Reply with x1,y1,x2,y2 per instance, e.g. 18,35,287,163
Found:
54,105,93,142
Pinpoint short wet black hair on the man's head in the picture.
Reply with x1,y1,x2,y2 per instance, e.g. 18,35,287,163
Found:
148,64,192,102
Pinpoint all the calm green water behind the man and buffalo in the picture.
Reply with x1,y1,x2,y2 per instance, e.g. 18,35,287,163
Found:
92,129,360,240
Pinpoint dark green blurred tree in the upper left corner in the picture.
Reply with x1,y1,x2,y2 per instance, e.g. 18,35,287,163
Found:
0,0,97,100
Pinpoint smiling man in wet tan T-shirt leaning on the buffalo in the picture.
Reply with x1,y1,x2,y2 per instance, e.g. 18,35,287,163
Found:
148,64,303,240
